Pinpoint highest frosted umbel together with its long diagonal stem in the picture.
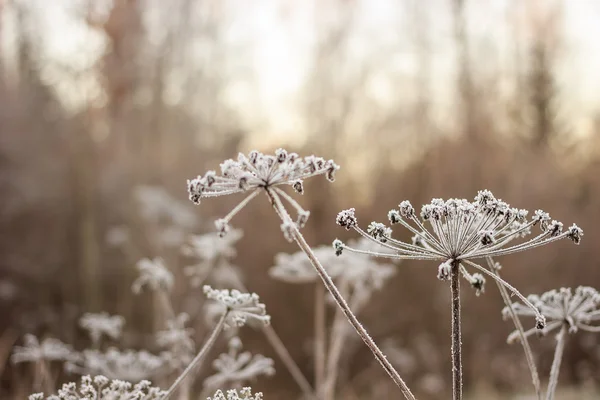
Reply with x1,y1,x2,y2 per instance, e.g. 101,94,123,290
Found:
188,149,415,400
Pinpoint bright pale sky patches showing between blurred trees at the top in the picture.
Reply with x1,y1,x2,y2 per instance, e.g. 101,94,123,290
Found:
1,0,600,144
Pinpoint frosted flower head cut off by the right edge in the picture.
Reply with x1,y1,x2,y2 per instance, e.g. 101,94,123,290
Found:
502,286,600,342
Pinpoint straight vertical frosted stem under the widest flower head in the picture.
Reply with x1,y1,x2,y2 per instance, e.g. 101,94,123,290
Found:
450,260,462,400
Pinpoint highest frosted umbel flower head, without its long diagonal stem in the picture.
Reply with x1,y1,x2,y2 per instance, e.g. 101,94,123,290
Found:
187,149,339,236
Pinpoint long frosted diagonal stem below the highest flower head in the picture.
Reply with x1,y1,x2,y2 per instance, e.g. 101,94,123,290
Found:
265,188,416,400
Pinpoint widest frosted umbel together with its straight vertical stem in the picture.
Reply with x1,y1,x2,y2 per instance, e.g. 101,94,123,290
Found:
333,190,583,400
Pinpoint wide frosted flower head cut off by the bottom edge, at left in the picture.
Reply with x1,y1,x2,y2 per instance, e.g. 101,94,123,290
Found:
29,375,166,400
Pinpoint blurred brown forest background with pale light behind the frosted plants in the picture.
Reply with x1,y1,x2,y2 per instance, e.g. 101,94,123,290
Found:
0,0,600,399
